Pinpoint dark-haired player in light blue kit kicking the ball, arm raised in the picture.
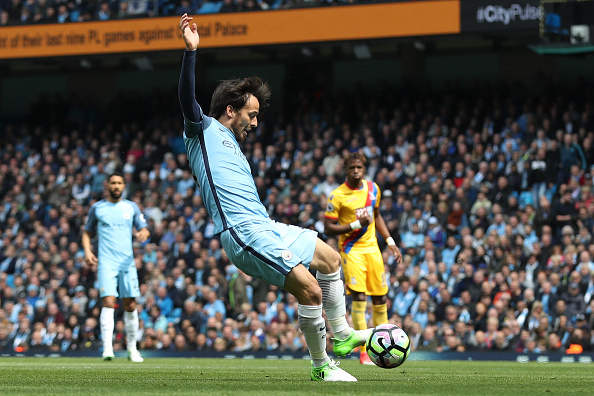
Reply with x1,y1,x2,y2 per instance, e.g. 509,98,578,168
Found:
179,14,371,382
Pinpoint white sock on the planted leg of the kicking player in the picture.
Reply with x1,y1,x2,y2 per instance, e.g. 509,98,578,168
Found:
297,304,330,367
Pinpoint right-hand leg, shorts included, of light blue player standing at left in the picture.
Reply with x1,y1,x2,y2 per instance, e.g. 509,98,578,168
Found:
119,268,144,363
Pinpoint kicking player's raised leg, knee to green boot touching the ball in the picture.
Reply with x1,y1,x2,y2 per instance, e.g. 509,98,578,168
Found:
310,239,371,356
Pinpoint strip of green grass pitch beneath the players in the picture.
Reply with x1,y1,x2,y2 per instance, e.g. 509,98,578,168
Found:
0,357,594,396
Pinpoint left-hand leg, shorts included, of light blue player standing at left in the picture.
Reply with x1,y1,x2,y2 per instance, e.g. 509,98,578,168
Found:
97,265,118,360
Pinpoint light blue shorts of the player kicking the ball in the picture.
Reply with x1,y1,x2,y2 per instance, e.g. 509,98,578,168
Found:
221,221,318,288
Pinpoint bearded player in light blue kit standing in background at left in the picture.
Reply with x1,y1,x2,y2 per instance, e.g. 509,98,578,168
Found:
82,173,150,363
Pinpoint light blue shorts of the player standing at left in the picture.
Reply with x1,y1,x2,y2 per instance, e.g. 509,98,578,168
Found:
97,264,140,298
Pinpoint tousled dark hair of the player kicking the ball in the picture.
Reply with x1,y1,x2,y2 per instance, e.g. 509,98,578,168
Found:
209,77,270,119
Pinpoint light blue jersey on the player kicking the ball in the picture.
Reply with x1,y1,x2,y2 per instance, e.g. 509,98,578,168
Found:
184,109,271,233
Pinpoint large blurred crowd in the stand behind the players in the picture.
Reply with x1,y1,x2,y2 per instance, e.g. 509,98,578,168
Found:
0,75,594,353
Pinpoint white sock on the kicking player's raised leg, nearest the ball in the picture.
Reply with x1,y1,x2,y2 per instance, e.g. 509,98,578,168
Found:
316,271,353,340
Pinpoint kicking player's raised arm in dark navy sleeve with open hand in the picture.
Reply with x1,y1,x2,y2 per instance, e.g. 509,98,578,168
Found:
178,14,202,131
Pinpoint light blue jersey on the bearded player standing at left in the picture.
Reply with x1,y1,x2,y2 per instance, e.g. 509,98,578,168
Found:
85,199,147,270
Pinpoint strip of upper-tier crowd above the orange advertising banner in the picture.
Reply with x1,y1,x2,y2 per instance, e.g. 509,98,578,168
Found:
0,0,354,26
